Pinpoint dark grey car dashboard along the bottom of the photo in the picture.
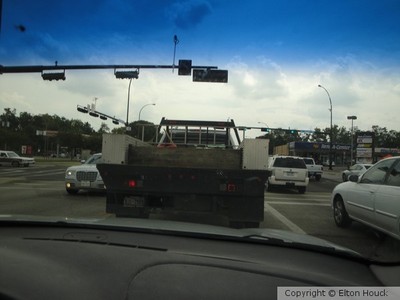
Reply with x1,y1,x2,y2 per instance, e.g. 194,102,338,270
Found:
0,224,400,299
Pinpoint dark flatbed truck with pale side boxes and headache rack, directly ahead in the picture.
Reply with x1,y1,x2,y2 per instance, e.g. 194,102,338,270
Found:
97,118,269,228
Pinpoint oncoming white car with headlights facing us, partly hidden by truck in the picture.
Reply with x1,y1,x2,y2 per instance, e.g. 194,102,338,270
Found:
65,153,105,194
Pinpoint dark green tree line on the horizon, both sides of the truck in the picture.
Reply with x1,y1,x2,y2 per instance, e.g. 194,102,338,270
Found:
0,108,400,156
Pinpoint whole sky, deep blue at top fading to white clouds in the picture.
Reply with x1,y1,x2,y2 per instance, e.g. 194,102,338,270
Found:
0,0,400,135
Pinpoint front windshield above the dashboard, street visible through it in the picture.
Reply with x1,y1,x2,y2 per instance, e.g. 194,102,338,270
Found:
0,0,400,262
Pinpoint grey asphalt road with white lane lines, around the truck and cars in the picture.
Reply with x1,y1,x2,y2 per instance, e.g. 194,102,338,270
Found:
0,161,400,261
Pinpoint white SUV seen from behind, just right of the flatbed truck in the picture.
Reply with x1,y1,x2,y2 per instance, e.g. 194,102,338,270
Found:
266,156,309,194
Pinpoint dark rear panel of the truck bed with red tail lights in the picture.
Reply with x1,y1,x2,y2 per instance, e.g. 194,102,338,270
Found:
97,164,268,197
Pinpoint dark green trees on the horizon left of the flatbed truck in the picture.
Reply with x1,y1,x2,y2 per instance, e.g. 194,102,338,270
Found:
0,108,155,156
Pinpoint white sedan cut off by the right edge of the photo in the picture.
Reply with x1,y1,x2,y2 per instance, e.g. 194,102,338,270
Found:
331,157,400,239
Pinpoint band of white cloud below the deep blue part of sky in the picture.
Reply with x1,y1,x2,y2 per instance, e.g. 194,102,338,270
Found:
0,58,400,135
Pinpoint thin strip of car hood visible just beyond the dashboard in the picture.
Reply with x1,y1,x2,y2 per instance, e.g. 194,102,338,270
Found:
0,215,362,259
